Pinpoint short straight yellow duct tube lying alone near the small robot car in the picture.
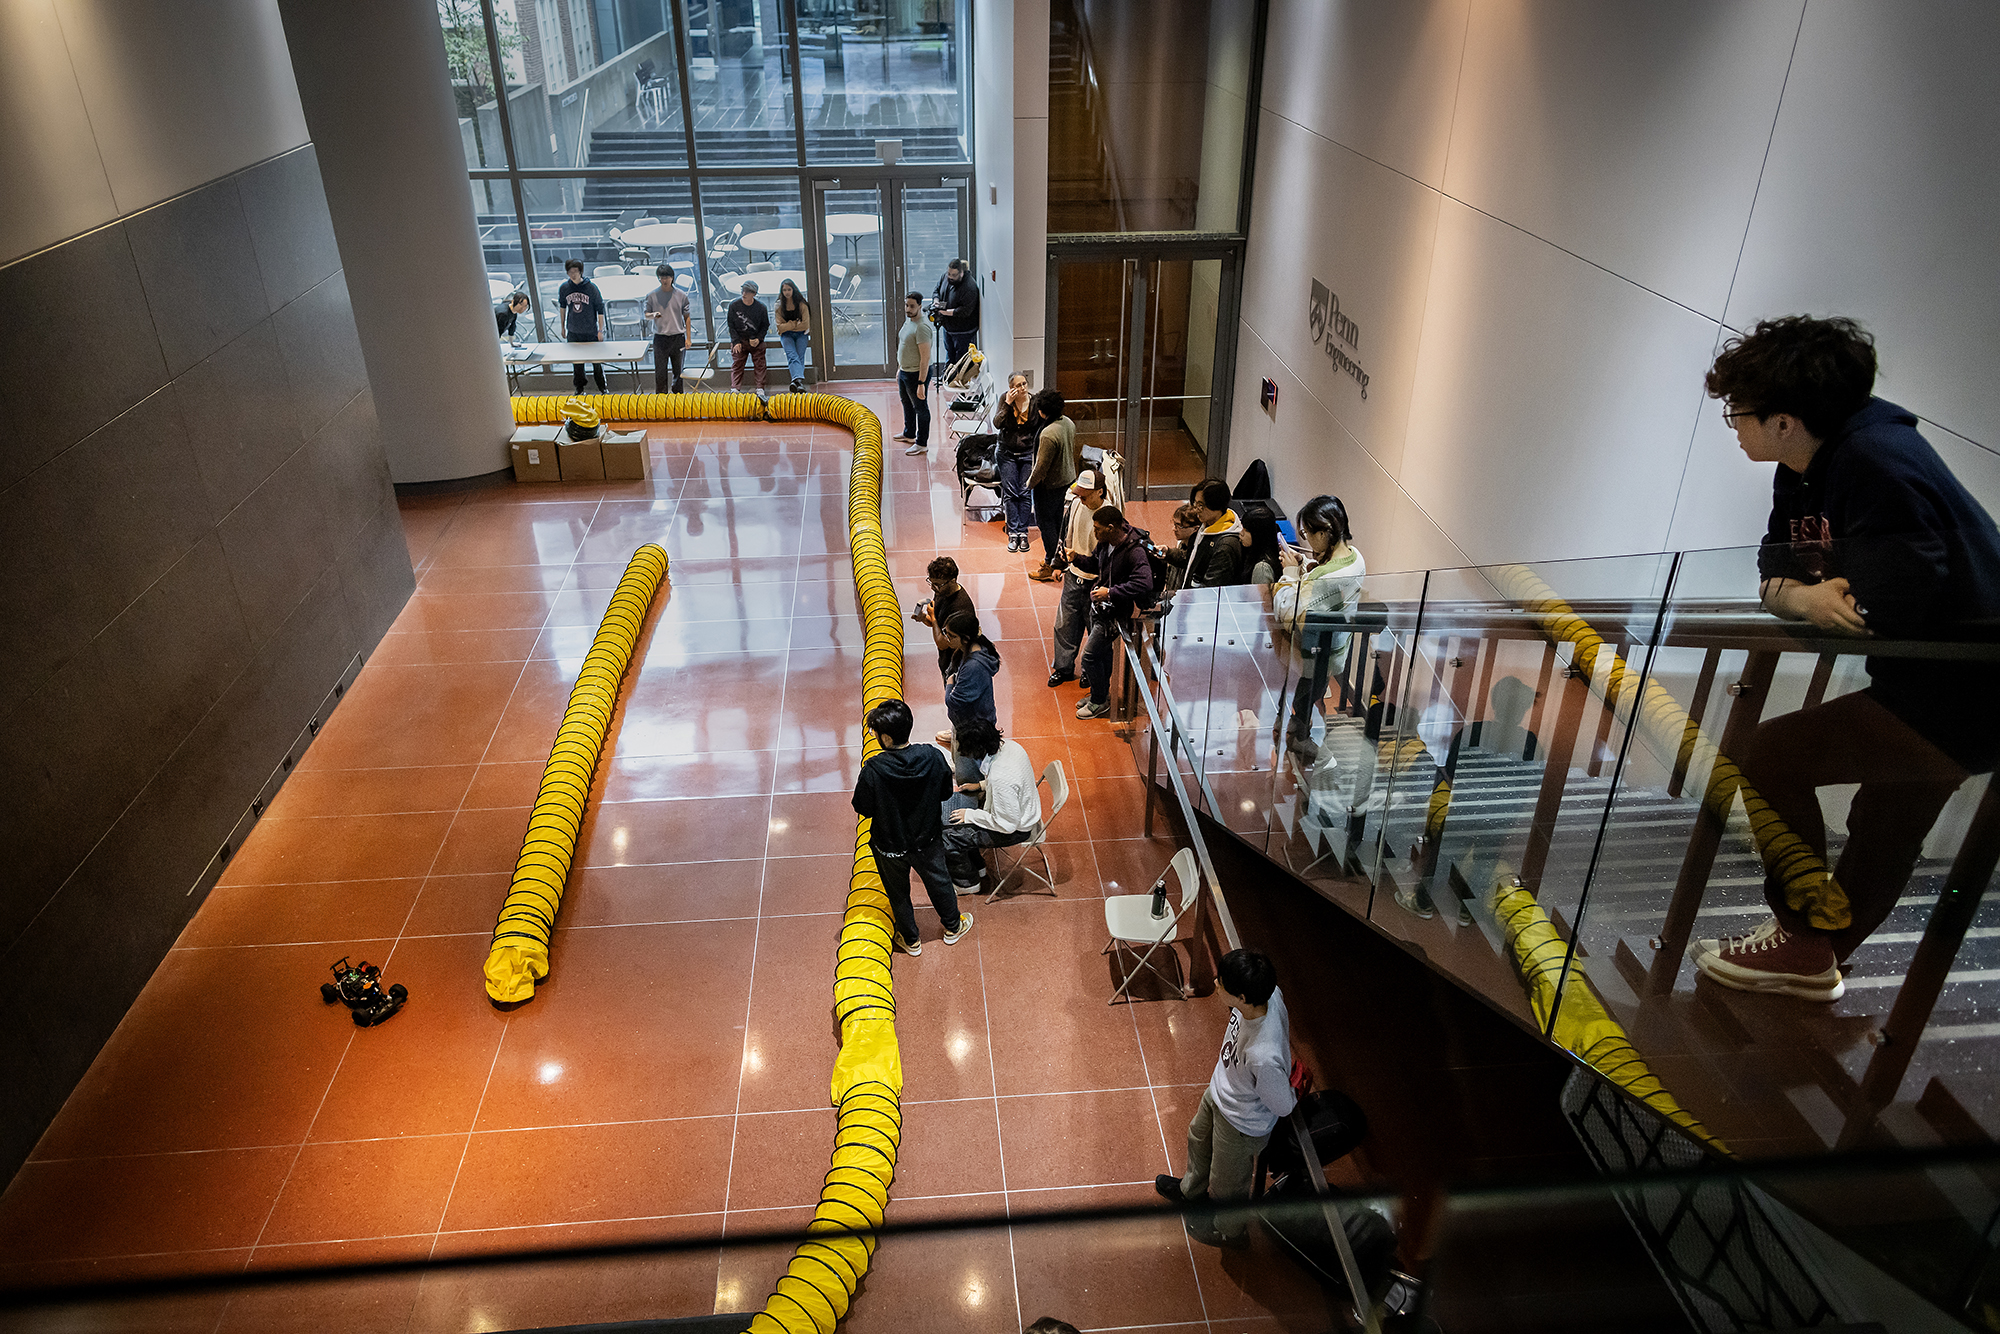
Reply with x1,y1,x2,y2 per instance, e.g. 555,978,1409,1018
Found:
486,544,666,1004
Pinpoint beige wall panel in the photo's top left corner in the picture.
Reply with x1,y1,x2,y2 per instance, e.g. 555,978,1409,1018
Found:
0,0,118,264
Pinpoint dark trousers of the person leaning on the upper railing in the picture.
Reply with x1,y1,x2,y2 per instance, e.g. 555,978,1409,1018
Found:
1740,690,1966,960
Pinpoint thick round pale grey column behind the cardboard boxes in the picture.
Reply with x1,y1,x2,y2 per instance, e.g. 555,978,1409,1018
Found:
278,0,514,482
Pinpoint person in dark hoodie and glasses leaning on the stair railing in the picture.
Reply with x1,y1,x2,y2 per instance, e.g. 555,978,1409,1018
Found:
1694,316,2000,1000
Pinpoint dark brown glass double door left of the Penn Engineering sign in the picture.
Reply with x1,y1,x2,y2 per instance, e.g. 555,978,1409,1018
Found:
1050,256,1228,500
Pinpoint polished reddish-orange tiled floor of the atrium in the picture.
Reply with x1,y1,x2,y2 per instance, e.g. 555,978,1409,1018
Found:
0,386,1324,1332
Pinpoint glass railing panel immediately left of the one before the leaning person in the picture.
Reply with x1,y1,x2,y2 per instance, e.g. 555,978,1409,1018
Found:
1362,556,1672,1046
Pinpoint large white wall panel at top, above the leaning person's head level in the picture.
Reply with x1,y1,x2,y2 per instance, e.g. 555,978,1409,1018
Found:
1444,0,1800,318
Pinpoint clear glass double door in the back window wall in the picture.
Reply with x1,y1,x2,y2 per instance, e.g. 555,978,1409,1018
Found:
812,176,970,380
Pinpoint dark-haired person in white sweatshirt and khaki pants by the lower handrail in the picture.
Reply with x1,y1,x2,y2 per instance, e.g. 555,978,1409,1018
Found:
1152,950,1298,1246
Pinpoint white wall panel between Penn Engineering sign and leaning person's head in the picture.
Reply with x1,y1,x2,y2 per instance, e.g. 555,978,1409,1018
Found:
1398,200,1716,564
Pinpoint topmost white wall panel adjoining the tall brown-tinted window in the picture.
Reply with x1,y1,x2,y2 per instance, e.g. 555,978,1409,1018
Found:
1258,0,1468,188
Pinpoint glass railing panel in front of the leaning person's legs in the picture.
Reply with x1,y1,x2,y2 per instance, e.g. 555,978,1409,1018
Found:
1578,544,2000,1154
